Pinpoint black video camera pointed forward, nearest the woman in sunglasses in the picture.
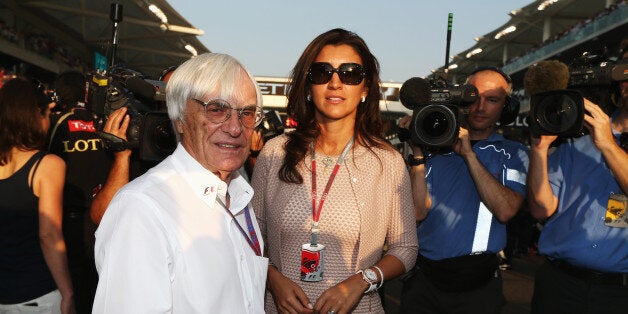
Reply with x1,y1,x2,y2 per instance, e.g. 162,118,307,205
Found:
399,77,478,147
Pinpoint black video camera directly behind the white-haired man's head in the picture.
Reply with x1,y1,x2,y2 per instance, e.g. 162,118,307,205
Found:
87,66,177,161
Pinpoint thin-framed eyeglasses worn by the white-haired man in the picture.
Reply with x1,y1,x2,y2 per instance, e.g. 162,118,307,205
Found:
191,98,264,128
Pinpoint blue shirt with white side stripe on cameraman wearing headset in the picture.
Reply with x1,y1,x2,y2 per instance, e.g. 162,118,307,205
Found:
417,133,528,260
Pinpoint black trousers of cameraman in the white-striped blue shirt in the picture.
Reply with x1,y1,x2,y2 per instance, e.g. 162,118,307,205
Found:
401,269,505,314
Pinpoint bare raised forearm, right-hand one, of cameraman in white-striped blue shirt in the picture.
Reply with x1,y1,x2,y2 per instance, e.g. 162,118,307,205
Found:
454,128,523,222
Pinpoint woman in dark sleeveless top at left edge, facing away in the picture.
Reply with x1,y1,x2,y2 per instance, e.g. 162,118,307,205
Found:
0,78,74,313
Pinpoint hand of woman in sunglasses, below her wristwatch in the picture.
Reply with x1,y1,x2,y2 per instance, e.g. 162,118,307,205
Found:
314,274,369,314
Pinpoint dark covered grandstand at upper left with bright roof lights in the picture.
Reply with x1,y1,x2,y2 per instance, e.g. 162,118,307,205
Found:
0,0,209,80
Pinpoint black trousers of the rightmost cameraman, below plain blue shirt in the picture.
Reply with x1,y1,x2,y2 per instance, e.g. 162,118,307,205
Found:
532,262,628,314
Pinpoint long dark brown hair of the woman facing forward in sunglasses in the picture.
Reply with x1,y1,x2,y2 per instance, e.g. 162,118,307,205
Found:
279,28,391,184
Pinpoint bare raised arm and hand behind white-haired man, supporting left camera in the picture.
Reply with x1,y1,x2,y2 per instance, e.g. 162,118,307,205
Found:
89,107,131,225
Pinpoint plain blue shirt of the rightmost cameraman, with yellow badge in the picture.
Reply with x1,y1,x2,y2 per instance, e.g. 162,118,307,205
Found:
539,130,628,273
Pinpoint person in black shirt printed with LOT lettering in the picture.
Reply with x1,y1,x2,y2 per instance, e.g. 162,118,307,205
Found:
48,71,111,313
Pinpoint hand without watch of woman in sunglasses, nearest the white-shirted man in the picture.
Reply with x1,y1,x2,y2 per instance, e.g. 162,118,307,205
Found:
268,266,314,313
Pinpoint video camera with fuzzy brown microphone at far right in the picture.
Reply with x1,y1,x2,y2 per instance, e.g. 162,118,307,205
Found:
526,52,628,137
